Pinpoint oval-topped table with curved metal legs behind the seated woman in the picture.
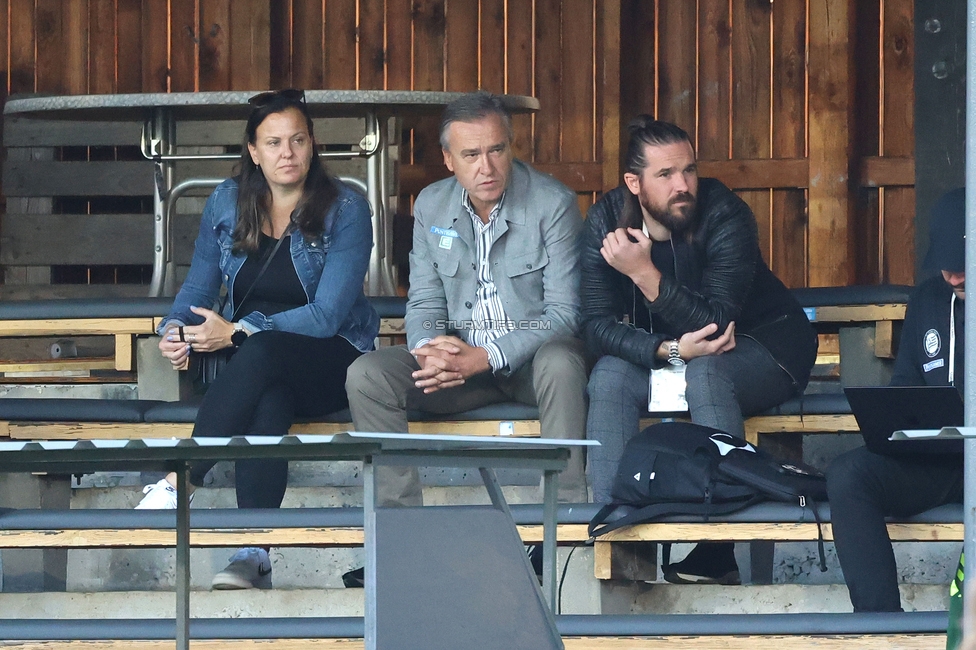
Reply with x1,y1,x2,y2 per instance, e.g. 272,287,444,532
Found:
4,90,539,297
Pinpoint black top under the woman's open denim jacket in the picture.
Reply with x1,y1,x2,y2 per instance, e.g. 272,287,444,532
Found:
234,233,308,318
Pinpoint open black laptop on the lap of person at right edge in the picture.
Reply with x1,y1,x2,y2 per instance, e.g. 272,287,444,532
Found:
844,386,963,456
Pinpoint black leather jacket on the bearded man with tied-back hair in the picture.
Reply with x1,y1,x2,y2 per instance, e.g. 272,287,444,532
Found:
580,178,817,393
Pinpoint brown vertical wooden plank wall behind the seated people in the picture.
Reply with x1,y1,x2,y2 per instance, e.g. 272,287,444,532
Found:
0,0,914,286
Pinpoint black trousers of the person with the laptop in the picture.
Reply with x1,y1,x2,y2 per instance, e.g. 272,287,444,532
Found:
827,447,963,612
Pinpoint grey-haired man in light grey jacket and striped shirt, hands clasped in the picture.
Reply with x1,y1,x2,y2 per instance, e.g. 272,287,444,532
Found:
346,91,587,507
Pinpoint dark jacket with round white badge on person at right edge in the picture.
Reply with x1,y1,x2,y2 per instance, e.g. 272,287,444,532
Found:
891,275,966,391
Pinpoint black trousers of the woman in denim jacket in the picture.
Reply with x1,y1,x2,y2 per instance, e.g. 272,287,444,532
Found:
190,331,362,508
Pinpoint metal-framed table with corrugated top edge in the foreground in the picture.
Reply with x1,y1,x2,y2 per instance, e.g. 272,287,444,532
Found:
0,432,598,650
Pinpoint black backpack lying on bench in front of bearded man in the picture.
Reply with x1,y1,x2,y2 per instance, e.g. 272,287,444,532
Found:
589,422,827,571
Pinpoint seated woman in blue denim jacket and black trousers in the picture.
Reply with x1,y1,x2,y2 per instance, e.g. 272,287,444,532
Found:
137,90,379,589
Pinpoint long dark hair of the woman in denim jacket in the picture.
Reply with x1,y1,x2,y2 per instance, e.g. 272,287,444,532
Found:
234,93,339,253
